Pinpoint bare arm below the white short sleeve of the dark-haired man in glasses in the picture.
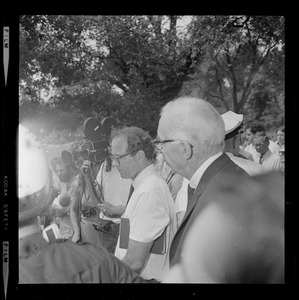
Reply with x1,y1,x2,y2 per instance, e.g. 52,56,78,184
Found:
122,239,154,273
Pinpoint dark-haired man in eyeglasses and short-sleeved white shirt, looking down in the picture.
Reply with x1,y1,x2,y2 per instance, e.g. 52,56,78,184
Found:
111,127,176,280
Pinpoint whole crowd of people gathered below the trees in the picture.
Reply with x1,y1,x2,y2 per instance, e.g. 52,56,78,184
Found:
18,97,285,283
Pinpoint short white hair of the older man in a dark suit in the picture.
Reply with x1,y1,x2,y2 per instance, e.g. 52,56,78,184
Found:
160,97,225,157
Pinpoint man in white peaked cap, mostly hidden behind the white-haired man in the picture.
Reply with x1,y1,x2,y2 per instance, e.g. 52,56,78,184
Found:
221,110,262,176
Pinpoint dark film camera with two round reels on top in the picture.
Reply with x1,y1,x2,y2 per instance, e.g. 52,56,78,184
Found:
61,117,117,163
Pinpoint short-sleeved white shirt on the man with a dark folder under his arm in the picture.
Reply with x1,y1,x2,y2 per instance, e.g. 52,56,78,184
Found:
115,165,176,280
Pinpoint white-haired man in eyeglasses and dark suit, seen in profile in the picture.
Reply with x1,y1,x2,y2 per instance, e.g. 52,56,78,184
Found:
155,97,249,267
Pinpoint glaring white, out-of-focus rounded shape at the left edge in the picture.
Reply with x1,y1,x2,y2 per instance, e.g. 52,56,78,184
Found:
18,125,51,225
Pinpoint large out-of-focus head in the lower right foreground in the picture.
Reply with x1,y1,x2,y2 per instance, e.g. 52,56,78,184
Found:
165,173,284,283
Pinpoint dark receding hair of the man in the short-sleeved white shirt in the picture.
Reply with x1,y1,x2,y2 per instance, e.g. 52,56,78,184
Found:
111,126,156,161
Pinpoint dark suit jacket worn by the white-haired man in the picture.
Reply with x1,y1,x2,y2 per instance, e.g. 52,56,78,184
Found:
169,153,249,267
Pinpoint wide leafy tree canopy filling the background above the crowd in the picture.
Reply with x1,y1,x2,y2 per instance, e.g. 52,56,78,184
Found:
20,15,284,139
